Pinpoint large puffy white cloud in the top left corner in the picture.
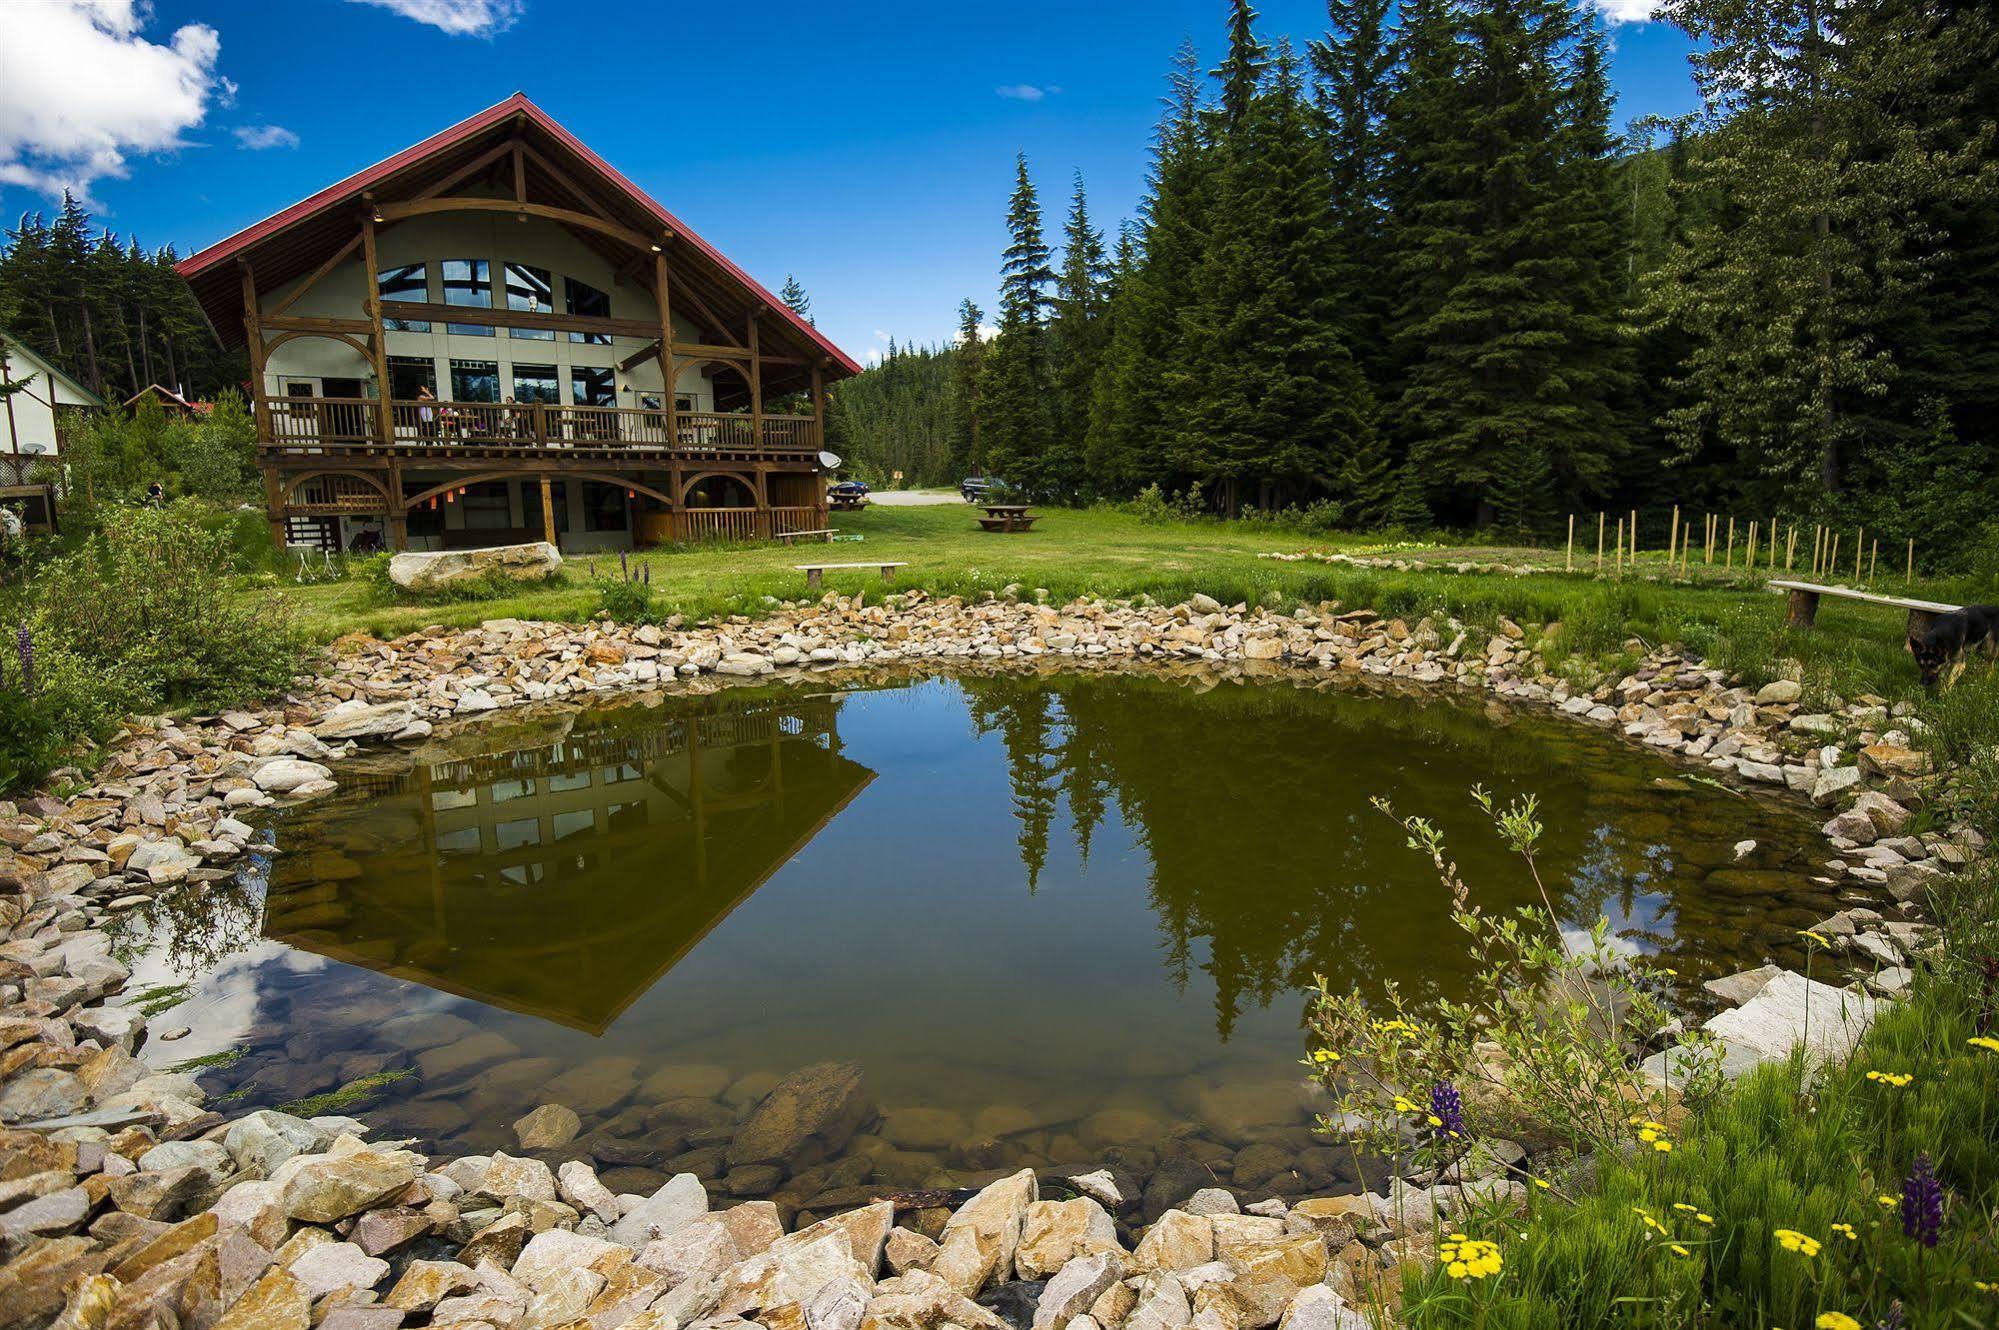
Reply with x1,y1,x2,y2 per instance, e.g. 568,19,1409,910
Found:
0,0,236,204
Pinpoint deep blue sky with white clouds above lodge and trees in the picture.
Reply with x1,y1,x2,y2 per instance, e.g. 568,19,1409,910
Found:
0,0,1695,358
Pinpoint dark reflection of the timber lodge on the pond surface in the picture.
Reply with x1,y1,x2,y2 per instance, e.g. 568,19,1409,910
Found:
264,692,874,1034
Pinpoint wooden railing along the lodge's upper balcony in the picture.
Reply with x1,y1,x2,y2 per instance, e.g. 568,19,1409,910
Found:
264,398,820,456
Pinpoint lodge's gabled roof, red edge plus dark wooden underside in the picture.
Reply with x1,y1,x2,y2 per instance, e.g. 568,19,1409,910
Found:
176,92,860,376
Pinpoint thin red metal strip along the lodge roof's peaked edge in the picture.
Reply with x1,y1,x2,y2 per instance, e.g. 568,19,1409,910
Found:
176,92,862,374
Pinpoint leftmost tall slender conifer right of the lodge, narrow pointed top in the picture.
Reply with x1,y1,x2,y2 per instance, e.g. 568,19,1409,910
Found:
980,154,1057,498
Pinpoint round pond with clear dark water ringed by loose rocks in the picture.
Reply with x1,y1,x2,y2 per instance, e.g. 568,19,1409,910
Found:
128,672,1847,1208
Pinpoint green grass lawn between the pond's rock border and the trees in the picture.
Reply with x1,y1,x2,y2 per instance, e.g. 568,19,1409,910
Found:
280,504,1993,712
